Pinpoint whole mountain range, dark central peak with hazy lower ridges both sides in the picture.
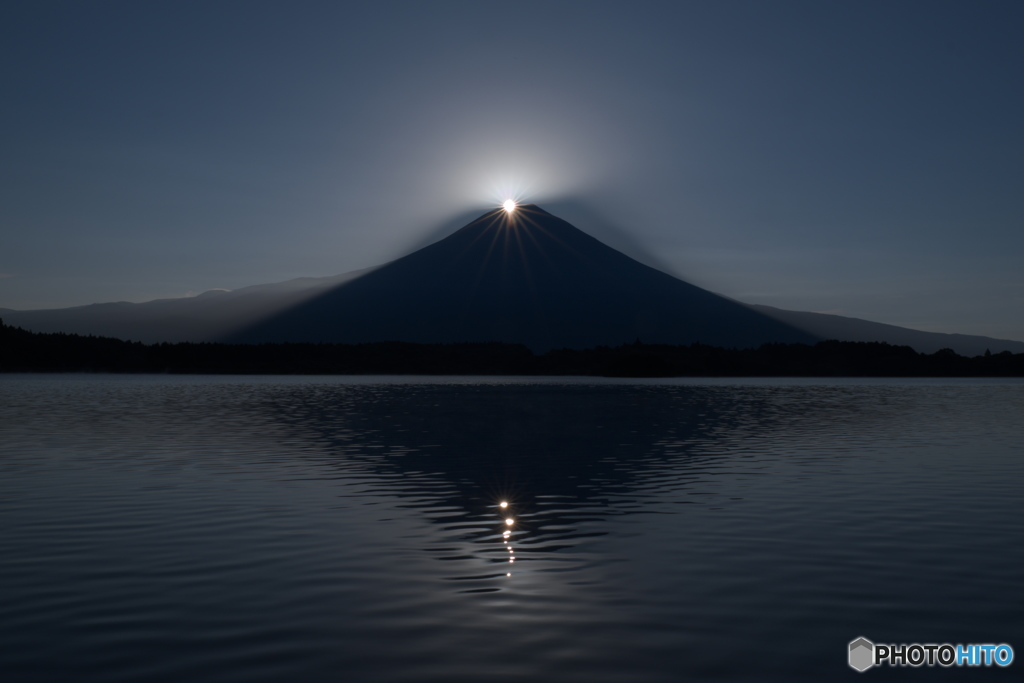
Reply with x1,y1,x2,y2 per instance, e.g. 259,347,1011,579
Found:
6,205,1024,355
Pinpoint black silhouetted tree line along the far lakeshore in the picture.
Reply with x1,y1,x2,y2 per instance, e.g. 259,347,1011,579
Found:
0,321,1024,377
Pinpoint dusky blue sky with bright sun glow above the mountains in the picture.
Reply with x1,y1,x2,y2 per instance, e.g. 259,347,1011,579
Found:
0,0,1024,340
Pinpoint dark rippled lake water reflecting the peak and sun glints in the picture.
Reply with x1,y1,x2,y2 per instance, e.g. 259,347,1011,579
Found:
0,375,1024,682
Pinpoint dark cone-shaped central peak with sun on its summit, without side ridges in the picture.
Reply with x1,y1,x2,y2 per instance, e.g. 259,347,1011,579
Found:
225,204,817,351
